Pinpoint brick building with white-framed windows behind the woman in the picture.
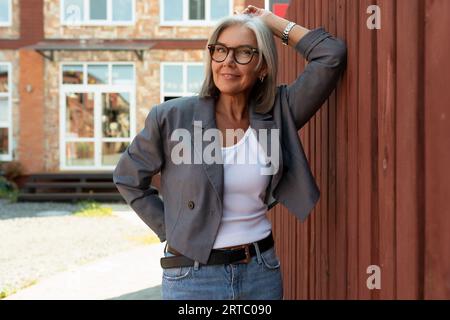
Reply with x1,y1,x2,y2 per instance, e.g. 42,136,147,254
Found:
0,0,260,173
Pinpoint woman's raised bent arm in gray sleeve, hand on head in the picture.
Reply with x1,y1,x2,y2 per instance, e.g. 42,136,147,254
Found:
243,6,347,130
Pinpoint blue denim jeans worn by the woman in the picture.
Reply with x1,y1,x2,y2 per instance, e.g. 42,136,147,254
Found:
162,244,283,300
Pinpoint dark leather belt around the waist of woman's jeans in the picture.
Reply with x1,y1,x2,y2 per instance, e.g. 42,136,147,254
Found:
161,233,274,269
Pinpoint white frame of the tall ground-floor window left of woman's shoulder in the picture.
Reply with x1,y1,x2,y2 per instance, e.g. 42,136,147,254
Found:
59,61,137,171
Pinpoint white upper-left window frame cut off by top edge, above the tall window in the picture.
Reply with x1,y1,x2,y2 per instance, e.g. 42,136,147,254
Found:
60,0,136,27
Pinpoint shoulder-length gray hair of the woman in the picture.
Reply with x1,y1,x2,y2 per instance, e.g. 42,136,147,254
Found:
200,14,278,113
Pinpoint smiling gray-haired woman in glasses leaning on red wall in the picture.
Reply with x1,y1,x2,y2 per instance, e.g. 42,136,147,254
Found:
114,6,346,299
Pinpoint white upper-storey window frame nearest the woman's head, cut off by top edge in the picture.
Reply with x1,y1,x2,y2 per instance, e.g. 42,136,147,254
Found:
159,0,234,27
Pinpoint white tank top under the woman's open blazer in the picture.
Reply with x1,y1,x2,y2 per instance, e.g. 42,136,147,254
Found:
213,127,272,249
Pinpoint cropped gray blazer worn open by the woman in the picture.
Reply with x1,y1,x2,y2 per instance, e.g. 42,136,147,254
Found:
114,28,347,263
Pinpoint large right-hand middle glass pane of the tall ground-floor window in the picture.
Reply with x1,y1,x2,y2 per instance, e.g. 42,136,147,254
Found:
102,93,130,138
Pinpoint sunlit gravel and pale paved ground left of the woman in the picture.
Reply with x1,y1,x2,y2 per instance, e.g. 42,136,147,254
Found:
0,204,164,300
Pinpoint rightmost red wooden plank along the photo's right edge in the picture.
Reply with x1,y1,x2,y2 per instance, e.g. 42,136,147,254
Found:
421,0,450,299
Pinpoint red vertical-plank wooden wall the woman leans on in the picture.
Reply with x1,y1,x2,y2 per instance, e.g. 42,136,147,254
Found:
244,0,450,299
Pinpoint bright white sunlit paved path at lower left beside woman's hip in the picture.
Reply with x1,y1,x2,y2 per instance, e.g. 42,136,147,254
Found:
5,244,164,300
